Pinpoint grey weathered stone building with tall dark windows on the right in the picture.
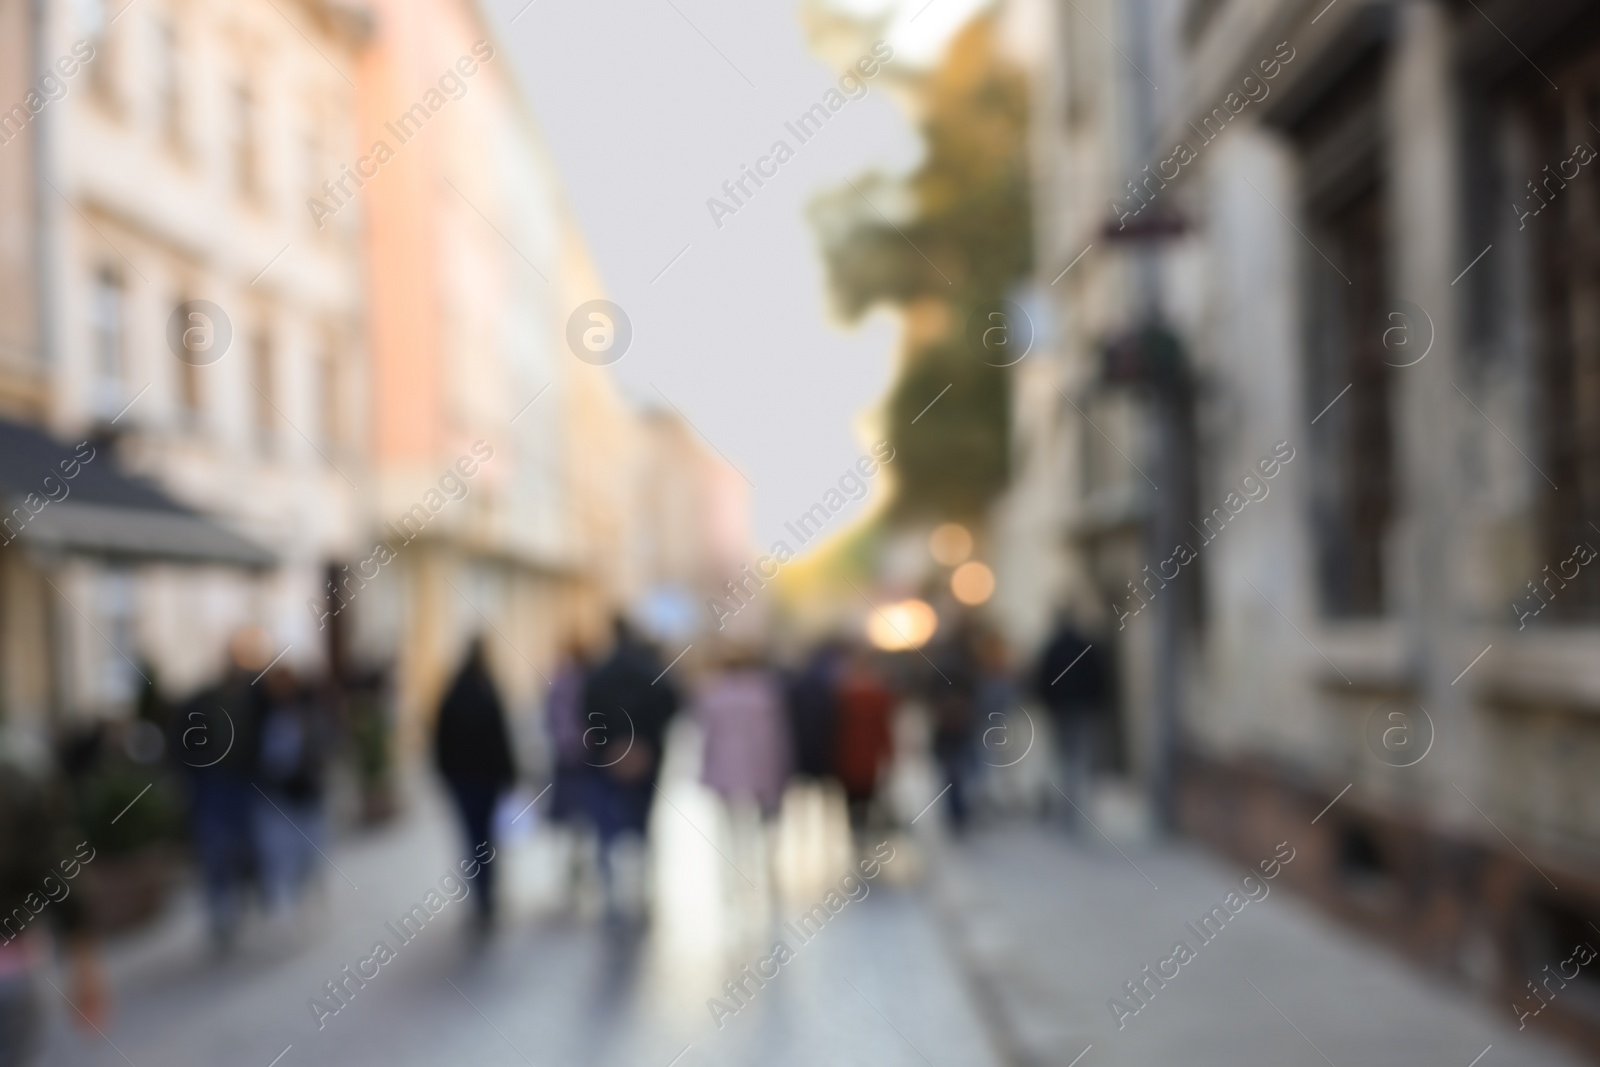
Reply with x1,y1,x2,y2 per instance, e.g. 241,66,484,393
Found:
1018,0,1600,1046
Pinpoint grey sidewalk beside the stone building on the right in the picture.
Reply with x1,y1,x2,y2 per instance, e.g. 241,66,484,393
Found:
938,824,1584,1067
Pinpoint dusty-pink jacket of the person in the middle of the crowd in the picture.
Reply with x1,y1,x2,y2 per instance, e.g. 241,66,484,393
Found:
694,651,789,817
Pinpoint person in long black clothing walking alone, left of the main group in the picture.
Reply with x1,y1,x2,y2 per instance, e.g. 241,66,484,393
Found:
434,635,517,926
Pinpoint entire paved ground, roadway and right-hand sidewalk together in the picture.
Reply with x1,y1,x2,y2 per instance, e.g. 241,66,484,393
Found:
45,735,1582,1067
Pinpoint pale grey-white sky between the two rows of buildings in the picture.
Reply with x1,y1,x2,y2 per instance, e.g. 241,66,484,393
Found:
486,0,982,545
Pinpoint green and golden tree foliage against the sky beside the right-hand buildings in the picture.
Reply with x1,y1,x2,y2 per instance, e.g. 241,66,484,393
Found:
811,18,1032,518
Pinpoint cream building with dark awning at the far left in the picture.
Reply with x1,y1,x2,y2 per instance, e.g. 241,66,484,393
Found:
0,0,366,742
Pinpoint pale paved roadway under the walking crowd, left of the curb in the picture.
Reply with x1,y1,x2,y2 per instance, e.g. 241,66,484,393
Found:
40,764,998,1067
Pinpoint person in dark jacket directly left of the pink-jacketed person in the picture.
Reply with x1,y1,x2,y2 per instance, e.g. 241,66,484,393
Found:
582,617,678,883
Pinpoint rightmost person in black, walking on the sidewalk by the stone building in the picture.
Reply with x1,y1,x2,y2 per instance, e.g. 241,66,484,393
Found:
1034,613,1110,822
